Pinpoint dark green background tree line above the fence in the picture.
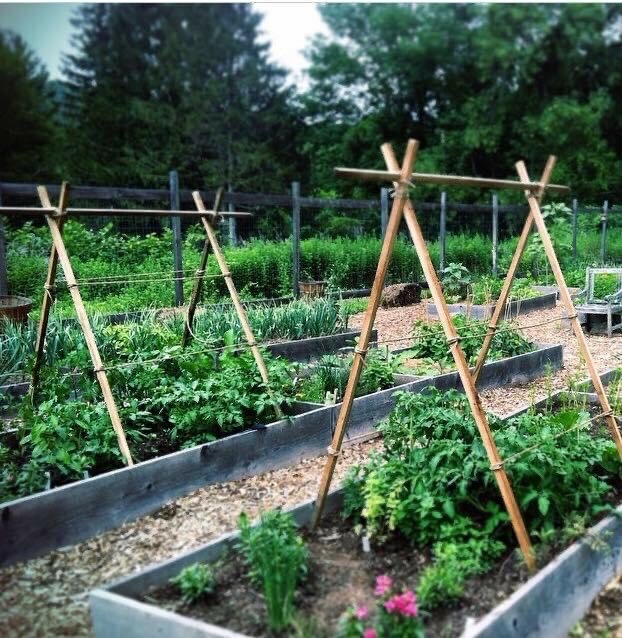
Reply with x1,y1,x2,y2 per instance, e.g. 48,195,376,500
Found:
0,4,622,201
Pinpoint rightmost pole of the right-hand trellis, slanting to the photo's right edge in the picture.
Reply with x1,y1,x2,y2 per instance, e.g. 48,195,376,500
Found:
516,161,622,458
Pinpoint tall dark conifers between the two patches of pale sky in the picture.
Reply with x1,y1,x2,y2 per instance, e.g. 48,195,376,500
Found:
64,4,303,192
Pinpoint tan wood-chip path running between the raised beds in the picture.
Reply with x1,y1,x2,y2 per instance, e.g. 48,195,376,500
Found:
0,302,622,637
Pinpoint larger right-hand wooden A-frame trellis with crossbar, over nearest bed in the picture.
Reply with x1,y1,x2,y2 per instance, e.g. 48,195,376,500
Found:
313,139,622,569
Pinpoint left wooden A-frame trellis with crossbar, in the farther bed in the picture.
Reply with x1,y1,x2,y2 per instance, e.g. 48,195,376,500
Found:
0,182,282,465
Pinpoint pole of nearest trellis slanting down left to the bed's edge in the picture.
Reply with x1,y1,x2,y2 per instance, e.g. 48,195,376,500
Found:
311,140,419,529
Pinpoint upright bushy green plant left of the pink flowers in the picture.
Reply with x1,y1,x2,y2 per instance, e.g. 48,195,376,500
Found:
239,510,308,632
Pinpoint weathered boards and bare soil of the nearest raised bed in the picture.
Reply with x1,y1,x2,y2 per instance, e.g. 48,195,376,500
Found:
90,384,622,638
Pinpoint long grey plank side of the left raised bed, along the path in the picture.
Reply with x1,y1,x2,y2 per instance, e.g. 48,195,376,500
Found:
0,345,562,565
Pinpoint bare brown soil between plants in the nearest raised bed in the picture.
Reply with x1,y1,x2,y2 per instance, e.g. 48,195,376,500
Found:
143,516,527,638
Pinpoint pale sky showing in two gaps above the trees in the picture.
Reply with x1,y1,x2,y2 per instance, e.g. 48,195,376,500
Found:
0,2,327,80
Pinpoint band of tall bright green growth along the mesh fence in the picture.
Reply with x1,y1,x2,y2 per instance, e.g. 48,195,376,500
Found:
8,220,622,315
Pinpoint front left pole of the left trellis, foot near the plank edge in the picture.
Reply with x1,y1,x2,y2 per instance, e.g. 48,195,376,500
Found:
37,188,134,465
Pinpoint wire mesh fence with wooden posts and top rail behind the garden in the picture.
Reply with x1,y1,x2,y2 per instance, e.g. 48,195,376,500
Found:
0,172,622,312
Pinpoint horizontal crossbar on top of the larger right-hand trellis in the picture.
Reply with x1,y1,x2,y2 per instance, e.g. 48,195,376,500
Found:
335,167,570,193
